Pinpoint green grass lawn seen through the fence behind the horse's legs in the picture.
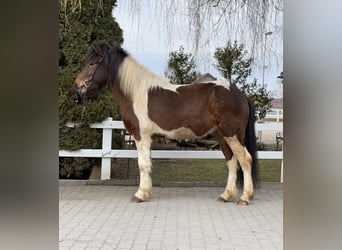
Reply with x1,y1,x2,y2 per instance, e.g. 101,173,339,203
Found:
112,144,281,185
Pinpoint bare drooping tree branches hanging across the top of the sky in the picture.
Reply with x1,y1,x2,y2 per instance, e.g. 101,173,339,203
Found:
119,0,283,61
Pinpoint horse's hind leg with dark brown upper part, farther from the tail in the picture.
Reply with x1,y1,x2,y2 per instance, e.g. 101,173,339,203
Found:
216,132,239,202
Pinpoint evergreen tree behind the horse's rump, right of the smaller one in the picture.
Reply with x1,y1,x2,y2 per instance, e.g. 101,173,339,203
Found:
214,41,272,120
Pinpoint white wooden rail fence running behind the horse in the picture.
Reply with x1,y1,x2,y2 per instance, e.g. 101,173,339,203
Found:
59,117,283,183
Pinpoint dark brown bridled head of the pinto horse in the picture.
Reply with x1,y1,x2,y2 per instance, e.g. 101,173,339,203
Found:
75,42,110,104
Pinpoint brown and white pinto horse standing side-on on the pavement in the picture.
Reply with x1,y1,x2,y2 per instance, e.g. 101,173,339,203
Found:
75,42,257,205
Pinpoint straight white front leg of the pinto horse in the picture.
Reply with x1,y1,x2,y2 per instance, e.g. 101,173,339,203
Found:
132,137,152,202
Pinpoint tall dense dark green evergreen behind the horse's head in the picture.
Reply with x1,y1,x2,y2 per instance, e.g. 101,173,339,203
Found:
59,0,123,177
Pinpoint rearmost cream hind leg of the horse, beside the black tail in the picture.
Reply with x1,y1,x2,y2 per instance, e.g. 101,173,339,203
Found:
225,136,254,205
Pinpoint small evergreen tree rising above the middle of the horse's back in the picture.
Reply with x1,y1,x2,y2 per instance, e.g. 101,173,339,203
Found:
165,46,199,85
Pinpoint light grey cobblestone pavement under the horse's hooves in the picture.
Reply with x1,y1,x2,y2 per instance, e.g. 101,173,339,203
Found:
59,183,283,250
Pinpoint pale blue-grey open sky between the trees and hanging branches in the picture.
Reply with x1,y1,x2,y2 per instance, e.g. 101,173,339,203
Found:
113,0,283,97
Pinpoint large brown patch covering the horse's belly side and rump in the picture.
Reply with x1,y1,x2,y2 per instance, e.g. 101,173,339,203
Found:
148,83,249,142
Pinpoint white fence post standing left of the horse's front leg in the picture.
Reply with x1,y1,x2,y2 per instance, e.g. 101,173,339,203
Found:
101,117,113,180
